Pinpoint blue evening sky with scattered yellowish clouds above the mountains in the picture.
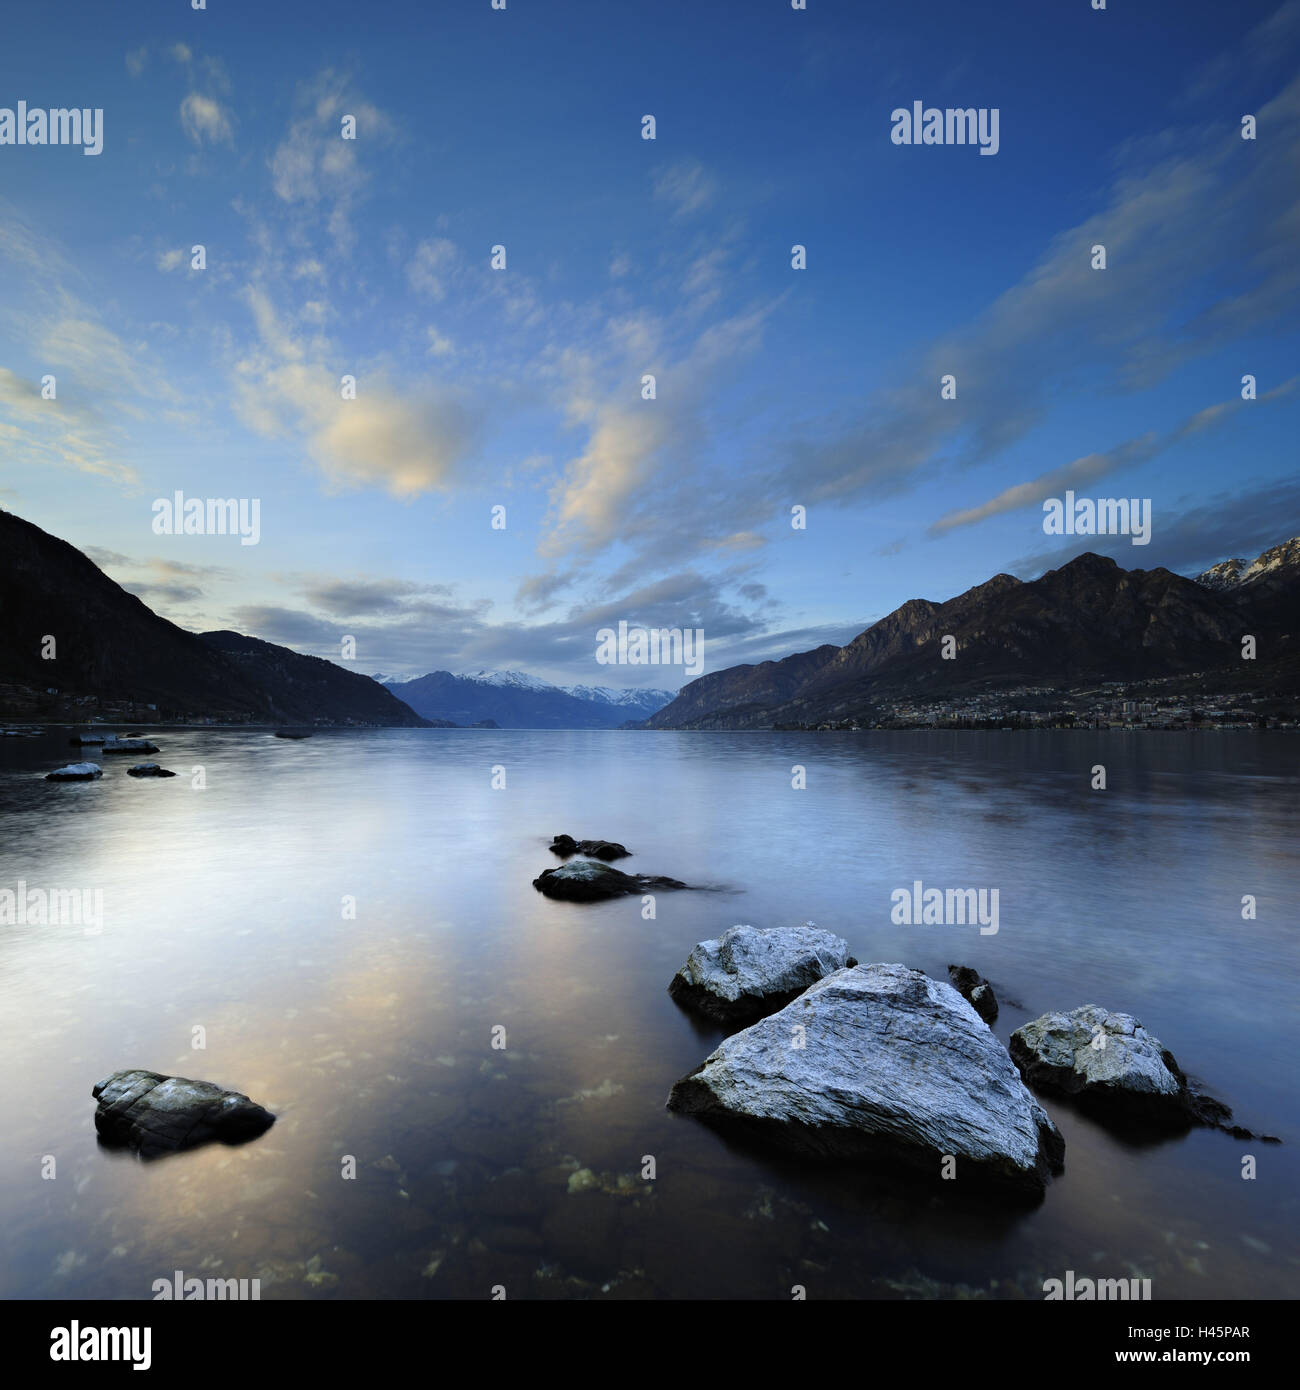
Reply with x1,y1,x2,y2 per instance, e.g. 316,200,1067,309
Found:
0,0,1300,688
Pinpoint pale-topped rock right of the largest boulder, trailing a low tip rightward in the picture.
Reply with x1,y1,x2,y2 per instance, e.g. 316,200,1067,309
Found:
1008,1004,1195,1123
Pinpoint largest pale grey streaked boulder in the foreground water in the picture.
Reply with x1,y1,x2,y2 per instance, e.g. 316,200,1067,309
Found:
667,965,1065,1197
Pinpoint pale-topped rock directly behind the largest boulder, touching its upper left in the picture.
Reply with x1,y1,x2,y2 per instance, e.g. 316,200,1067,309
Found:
667,922,858,1023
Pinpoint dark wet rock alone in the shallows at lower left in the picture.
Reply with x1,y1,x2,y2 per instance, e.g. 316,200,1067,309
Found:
90,1070,275,1158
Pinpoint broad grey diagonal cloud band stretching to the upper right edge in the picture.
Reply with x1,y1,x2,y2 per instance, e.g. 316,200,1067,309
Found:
779,66,1300,502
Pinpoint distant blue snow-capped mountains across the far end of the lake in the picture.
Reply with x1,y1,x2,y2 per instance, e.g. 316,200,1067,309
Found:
375,671,673,728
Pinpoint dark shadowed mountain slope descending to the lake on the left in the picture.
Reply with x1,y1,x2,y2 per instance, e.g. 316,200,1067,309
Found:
0,510,423,727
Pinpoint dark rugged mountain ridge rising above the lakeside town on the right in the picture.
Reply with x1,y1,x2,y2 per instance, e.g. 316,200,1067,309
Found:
647,541,1300,728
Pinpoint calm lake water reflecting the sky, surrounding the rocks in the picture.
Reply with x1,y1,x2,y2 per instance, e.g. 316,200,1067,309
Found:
0,730,1300,1298
